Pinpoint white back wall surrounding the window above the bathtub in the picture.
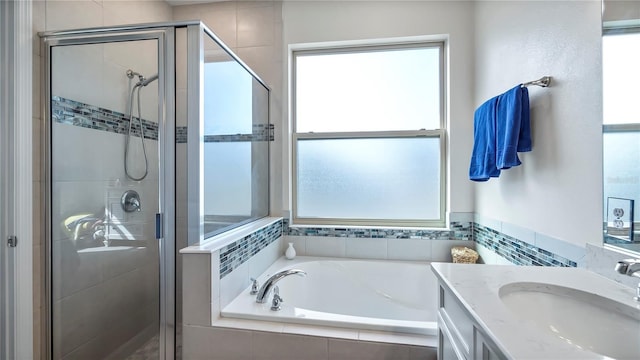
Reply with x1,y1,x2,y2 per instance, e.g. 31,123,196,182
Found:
276,1,474,217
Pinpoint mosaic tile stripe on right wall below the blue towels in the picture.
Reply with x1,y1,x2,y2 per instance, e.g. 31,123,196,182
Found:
473,223,577,267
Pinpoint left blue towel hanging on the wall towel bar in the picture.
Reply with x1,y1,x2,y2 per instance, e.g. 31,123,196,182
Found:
469,96,500,181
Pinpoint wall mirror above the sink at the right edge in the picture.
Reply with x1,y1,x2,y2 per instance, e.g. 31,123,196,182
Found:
602,0,640,252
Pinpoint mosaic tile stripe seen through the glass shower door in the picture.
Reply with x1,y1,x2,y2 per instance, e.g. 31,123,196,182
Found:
51,96,158,140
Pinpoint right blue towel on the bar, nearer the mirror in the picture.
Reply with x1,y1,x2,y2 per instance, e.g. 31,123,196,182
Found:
496,85,531,169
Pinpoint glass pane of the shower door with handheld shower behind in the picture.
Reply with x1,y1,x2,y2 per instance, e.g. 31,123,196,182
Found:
50,39,160,359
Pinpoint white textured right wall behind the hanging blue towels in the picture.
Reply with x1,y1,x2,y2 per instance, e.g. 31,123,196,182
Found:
476,0,602,247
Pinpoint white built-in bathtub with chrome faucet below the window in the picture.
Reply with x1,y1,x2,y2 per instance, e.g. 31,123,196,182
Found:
221,257,437,335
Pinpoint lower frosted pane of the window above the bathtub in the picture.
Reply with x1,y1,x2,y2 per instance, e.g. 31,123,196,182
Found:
297,138,440,220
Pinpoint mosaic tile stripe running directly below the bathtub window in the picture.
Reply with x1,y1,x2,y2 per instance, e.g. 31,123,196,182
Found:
283,219,473,241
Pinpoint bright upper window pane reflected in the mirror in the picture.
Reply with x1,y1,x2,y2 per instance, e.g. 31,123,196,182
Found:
602,34,640,124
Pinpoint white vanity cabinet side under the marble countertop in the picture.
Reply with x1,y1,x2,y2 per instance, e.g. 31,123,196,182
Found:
438,282,506,360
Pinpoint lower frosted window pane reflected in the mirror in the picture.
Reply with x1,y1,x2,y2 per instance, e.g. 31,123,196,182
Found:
603,132,640,219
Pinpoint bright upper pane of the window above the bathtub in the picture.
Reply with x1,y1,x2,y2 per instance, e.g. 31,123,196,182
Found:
295,47,441,133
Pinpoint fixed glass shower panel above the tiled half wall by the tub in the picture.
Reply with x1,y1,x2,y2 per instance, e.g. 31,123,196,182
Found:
203,34,271,237
